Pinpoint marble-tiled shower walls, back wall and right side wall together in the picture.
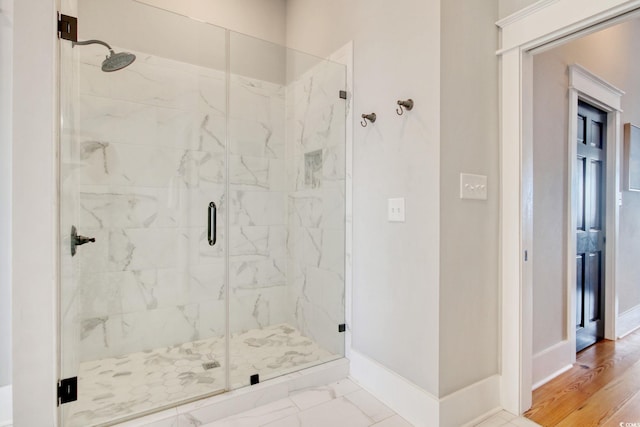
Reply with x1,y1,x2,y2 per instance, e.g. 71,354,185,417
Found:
64,48,345,362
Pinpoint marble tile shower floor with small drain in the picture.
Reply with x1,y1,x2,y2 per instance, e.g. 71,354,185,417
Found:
64,324,342,427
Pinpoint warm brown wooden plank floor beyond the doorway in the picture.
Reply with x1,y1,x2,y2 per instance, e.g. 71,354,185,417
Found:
525,330,640,427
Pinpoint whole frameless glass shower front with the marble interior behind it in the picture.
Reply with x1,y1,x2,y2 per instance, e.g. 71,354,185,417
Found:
59,0,346,427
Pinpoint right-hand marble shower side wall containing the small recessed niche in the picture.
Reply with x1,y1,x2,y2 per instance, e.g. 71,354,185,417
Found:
287,62,346,354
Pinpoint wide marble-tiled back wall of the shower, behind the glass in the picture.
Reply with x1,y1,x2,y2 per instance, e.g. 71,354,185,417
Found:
76,52,286,360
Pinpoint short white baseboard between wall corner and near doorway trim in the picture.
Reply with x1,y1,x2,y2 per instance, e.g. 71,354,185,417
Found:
440,375,501,427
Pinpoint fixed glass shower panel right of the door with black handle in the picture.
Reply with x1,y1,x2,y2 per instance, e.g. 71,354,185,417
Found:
229,32,346,388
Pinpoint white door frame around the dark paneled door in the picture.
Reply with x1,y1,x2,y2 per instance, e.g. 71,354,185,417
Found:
565,64,624,364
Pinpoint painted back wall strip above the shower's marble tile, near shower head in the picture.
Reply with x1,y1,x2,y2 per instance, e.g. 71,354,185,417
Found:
78,0,286,84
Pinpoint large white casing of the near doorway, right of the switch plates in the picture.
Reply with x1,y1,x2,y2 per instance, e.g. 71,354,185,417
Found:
497,0,640,414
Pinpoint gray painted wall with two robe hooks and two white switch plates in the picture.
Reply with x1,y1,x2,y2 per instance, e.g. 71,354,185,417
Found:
287,0,499,402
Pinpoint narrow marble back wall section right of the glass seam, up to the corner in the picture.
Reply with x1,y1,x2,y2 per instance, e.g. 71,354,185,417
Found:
229,75,287,332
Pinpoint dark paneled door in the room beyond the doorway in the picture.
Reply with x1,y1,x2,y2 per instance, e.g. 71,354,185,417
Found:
576,101,607,351
